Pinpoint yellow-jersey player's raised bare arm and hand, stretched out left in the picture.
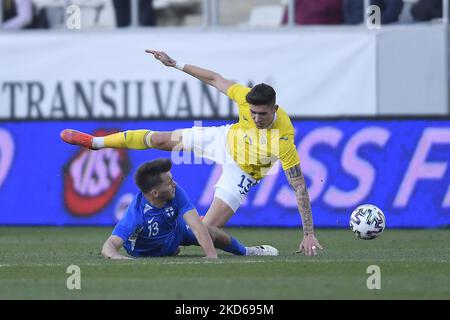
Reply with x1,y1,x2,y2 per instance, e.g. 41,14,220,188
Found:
145,50,235,94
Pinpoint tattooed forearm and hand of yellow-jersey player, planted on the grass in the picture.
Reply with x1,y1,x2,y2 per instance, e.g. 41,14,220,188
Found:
285,164,322,256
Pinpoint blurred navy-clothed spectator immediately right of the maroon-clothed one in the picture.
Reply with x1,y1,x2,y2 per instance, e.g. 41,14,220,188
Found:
343,0,402,24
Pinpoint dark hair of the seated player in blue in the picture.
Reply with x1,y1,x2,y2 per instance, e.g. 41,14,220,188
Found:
134,158,172,193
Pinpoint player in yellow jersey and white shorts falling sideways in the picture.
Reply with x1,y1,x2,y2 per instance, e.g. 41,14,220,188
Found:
61,50,322,256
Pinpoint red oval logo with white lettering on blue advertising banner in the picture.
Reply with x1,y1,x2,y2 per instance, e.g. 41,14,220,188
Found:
64,130,130,217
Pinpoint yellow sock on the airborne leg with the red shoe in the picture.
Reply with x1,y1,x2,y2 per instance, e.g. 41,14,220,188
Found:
104,130,154,150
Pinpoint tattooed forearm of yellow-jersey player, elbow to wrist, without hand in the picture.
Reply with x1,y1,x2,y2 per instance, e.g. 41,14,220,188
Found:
285,164,314,235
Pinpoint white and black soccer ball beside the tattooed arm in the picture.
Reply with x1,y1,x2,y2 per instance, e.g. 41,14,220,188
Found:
350,204,386,240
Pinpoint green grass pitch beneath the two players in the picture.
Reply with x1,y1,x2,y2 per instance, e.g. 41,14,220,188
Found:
0,227,450,300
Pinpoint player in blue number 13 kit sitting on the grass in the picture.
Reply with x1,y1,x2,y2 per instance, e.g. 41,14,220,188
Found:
102,159,278,259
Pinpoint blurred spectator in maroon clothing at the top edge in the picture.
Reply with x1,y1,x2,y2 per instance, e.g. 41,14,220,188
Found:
283,0,343,24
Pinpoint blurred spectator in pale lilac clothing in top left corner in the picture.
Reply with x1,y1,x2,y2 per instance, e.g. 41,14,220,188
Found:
2,0,33,30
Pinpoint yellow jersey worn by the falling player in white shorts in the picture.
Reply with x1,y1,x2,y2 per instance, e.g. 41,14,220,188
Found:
227,83,300,180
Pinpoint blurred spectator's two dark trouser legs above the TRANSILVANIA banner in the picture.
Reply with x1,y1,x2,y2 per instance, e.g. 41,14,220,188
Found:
113,0,156,27
